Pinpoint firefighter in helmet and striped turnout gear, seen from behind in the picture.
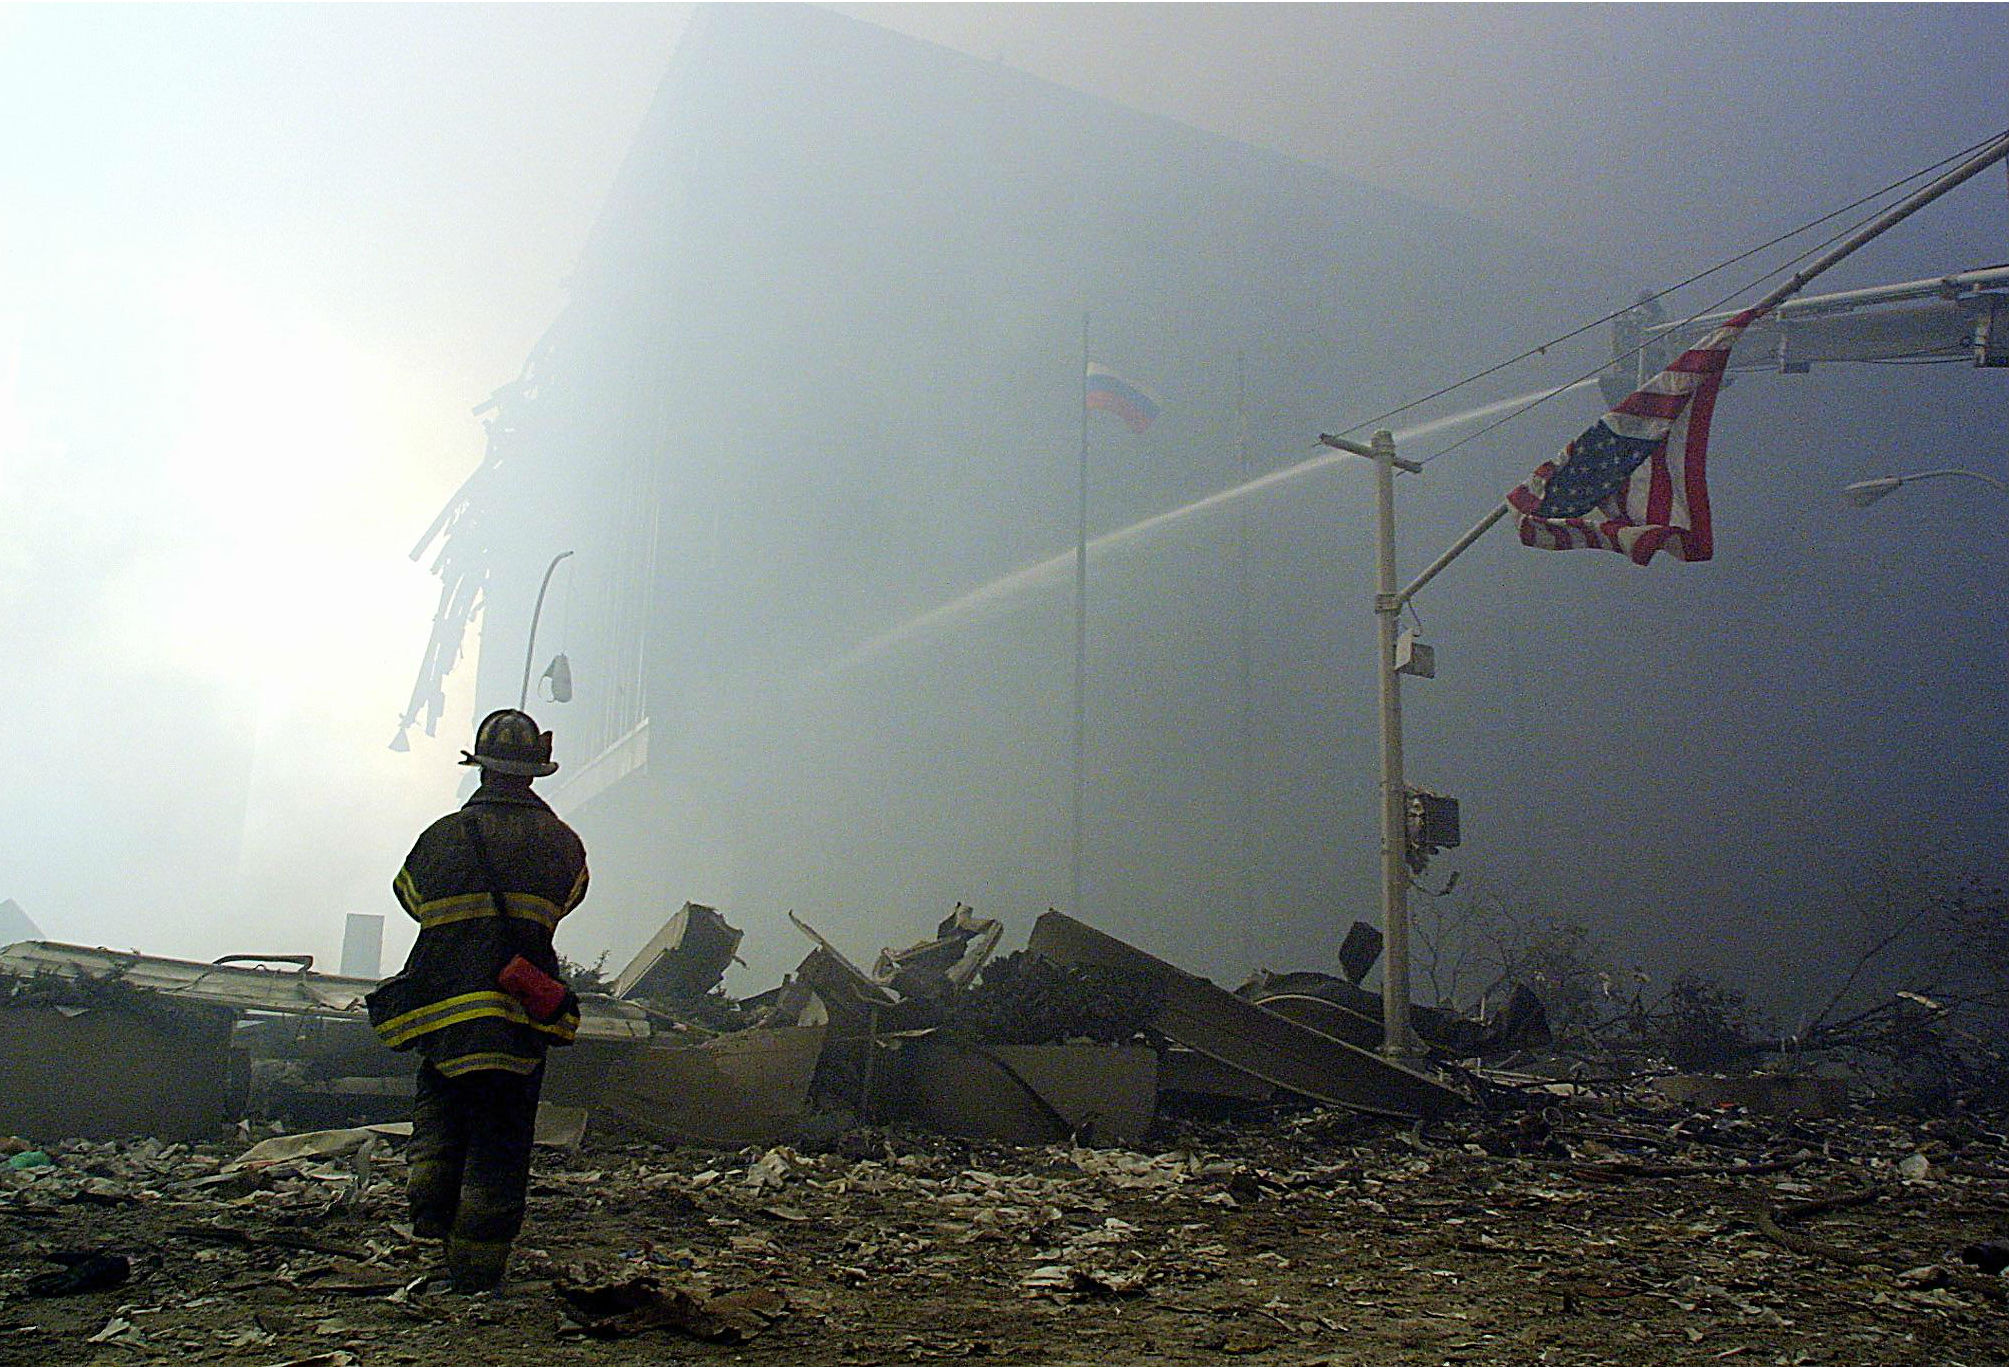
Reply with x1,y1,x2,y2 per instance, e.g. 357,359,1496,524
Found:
370,708,587,1291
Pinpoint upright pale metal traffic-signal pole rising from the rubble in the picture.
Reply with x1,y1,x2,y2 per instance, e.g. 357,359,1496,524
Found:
1372,428,1422,1059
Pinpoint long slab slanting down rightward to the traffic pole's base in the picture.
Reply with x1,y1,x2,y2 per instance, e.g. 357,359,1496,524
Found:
1031,911,1467,1118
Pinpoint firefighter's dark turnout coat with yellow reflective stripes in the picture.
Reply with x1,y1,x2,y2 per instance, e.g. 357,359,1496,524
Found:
370,784,587,1078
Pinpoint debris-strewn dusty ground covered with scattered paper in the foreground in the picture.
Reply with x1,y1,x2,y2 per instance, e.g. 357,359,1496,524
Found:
0,1094,2009,1367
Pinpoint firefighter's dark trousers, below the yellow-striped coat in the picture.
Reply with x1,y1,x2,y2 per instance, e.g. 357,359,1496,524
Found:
406,1063,544,1291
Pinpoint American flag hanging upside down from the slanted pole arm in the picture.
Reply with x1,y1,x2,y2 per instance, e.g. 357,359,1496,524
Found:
1507,308,1764,565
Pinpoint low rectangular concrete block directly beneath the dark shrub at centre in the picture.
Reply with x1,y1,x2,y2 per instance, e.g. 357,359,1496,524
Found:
898,1033,1157,1144
